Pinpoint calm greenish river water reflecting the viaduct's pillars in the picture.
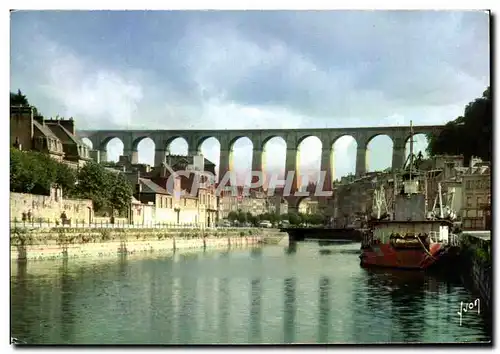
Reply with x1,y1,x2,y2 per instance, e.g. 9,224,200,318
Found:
11,242,491,344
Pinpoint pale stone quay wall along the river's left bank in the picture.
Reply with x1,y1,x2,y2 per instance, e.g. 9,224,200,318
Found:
10,228,288,260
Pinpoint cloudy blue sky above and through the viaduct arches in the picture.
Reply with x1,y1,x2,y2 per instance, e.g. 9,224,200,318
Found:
10,11,490,184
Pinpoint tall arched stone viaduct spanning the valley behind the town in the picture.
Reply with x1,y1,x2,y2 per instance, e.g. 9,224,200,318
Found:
77,125,443,196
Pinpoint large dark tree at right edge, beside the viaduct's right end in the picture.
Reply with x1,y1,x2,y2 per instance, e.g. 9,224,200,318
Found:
427,87,493,164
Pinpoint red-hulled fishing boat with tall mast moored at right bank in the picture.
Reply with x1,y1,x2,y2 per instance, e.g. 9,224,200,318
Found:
360,123,457,270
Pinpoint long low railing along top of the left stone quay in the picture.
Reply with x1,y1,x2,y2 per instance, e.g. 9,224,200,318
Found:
10,219,260,229
